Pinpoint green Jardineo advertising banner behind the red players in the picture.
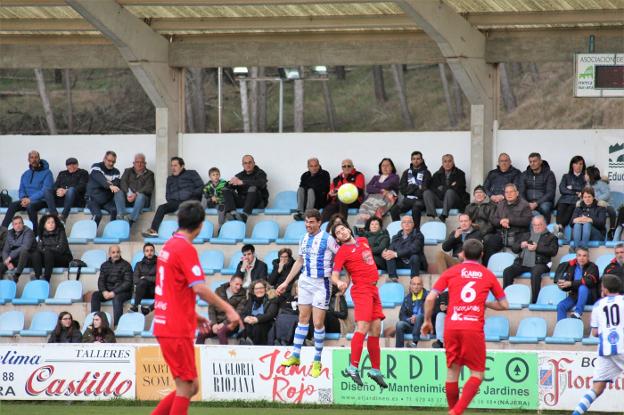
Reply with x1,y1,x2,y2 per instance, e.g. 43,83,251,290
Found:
333,349,538,409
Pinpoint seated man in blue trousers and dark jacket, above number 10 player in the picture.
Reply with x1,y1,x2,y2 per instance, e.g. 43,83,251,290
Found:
554,248,600,321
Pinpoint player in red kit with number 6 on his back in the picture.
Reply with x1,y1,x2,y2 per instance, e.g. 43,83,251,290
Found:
421,239,509,415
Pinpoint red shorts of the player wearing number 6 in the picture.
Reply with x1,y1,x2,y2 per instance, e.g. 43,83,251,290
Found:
444,330,485,372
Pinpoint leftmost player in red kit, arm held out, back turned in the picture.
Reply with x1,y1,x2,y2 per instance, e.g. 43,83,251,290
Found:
152,201,240,415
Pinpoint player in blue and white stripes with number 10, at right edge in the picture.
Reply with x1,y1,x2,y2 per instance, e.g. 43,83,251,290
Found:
572,274,624,415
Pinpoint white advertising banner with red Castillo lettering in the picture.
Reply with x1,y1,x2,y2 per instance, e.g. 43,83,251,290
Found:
0,344,135,401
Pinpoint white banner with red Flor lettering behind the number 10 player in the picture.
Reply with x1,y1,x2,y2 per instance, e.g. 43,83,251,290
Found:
538,350,624,414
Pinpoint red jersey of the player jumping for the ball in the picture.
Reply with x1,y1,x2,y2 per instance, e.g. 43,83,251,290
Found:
334,238,379,285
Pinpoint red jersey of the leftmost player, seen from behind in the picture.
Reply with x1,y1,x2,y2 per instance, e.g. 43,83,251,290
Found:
154,233,204,338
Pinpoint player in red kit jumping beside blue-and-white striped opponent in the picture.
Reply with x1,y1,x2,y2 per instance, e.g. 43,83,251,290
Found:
331,224,388,389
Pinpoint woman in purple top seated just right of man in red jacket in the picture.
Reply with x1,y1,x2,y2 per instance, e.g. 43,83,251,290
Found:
355,158,399,230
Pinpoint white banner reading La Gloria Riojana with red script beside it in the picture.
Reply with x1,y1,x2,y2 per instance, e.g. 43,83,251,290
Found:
201,346,332,404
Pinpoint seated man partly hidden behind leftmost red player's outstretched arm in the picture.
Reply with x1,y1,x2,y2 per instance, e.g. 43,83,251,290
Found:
196,275,247,344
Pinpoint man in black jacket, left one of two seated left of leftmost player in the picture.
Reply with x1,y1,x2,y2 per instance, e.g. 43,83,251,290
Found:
91,245,132,326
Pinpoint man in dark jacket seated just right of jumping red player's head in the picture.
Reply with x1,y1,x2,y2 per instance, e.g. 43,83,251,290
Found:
381,215,427,282
